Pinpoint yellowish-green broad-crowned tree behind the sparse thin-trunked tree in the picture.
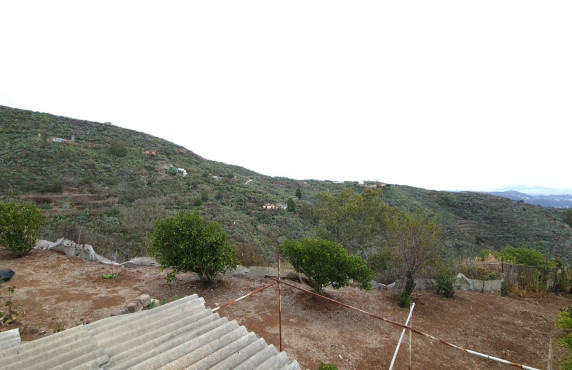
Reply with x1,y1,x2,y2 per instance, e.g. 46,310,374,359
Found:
315,189,392,253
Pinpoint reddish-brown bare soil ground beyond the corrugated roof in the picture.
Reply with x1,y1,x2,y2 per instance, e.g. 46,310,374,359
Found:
0,248,572,369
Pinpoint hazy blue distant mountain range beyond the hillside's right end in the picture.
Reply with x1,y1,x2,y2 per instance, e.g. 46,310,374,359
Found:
483,186,572,208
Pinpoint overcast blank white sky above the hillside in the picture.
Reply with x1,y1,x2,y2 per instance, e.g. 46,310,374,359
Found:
0,0,572,190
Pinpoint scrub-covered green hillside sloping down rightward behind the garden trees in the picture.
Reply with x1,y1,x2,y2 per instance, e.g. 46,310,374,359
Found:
0,106,572,264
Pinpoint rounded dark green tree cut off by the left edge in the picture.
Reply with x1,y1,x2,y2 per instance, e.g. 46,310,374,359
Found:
0,202,45,257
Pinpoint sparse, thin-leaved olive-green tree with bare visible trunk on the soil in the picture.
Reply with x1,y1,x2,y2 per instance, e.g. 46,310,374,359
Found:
389,210,442,294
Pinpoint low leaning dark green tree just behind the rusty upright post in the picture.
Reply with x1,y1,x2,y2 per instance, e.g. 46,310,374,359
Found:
278,238,374,292
